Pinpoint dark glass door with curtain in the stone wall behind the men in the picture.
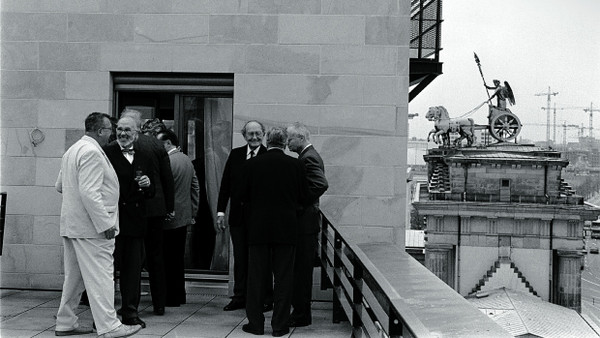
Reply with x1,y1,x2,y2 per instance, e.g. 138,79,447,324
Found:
115,90,233,274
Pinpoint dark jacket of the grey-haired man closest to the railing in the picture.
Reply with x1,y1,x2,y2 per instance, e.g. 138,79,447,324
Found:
298,145,329,234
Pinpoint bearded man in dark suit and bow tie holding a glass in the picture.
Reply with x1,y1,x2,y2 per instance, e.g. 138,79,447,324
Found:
104,117,156,327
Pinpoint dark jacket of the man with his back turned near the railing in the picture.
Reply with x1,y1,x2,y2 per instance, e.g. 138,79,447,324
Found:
241,149,308,245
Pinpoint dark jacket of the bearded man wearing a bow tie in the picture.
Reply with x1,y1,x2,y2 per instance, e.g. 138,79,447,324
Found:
104,142,157,237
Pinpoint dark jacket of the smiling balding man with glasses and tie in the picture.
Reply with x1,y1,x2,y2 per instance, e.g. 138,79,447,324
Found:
217,145,267,227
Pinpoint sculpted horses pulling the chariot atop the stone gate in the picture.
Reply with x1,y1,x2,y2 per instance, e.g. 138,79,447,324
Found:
425,106,474,147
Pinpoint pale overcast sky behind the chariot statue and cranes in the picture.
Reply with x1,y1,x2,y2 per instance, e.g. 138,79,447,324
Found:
409,0,600,144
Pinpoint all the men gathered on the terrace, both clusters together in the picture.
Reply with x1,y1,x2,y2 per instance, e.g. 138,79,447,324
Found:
55,110,328,337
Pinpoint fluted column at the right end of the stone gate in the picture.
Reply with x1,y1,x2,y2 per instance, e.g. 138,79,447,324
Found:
556,250,583,313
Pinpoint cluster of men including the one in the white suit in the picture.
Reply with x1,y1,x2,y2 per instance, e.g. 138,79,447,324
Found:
55,110,199,337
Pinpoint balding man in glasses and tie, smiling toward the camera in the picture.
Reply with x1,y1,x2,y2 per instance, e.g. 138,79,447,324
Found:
215,121,267,311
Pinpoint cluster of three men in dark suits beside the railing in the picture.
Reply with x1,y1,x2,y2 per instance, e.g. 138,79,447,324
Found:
216,121,328,337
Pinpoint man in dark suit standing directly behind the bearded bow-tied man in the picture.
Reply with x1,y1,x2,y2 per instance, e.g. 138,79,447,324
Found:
121,108,176,316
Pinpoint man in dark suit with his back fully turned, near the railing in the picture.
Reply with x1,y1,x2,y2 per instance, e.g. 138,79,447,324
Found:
241,127,307,337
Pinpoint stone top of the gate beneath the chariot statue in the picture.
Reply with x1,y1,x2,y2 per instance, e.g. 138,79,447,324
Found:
414,143,600,311
